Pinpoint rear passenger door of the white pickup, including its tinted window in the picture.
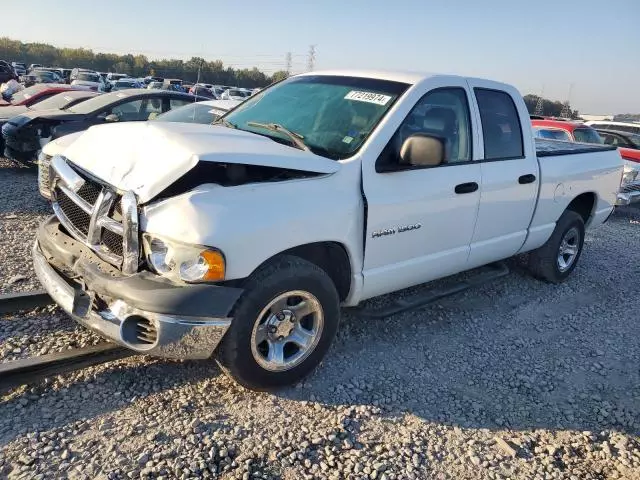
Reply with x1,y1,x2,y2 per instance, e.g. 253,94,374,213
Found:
468,79,540,268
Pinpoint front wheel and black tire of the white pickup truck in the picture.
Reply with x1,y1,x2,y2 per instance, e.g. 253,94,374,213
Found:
217,255,340,390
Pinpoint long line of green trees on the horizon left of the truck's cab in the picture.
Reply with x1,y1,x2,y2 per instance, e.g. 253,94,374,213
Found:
0,37,287,88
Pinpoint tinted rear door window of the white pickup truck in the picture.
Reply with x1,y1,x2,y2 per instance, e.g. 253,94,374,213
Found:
475,88,524,160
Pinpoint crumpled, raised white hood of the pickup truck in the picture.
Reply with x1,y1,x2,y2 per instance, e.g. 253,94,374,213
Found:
64,121,340,203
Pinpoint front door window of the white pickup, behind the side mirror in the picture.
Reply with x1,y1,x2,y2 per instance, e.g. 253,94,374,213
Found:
376,88,471,171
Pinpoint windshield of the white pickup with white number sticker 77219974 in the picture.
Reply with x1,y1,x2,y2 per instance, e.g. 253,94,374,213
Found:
225,75,409,159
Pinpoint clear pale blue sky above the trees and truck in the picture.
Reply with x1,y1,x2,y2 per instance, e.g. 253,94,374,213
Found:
0,0,640,114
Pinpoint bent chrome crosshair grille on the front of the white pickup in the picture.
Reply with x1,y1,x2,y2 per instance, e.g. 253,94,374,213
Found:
51,156,140,274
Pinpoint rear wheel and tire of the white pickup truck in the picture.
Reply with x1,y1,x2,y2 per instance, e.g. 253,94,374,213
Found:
529,210,584,283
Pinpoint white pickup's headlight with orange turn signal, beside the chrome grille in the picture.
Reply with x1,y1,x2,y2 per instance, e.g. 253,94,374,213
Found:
142,233,225,283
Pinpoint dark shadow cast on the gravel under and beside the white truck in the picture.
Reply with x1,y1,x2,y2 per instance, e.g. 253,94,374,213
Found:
0,213,640,444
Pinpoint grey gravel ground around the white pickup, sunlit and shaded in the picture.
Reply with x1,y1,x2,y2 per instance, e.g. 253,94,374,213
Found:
0,163,640,480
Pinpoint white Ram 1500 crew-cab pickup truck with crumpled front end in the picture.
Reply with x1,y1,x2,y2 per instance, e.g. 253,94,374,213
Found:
33,71,623,389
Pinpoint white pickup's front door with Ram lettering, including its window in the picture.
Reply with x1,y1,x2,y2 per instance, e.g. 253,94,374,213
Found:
363,78,481,298
